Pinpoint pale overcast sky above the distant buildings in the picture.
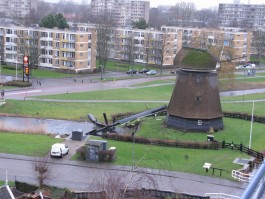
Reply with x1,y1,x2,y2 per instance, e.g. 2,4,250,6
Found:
46,0,265,9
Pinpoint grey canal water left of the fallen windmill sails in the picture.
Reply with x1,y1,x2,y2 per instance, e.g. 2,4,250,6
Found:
0,116,95,135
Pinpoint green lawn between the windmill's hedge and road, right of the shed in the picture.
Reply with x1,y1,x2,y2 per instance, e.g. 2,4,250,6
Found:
92,137,248,179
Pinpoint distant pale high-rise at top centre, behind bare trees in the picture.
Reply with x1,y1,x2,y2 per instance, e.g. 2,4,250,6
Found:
91,0,150,27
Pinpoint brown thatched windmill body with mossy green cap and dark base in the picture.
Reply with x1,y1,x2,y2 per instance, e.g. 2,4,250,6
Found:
165,47,224,132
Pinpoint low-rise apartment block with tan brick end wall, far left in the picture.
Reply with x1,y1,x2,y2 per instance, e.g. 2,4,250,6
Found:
0,26,96,72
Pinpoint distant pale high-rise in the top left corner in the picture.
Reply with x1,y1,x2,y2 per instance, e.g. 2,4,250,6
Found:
0,0,38,18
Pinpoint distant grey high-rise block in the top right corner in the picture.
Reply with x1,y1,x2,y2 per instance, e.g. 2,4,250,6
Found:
218,4,265,29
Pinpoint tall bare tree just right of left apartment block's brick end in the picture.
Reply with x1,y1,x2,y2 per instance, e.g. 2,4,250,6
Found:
96,12,115,79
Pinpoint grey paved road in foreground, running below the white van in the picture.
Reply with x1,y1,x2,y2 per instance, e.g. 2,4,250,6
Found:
0,154,247,196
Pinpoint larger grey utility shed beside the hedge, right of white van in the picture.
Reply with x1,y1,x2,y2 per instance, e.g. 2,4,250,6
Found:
86,140,107,162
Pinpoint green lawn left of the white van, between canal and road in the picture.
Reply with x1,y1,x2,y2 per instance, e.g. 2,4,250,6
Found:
0,132,62,156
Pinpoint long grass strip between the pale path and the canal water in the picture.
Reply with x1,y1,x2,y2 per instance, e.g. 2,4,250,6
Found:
0,100,164,121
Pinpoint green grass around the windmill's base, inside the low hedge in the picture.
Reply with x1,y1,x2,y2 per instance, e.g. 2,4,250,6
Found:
137,117,265,151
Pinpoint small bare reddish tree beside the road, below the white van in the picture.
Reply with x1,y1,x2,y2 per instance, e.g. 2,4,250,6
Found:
33,156,52,188
